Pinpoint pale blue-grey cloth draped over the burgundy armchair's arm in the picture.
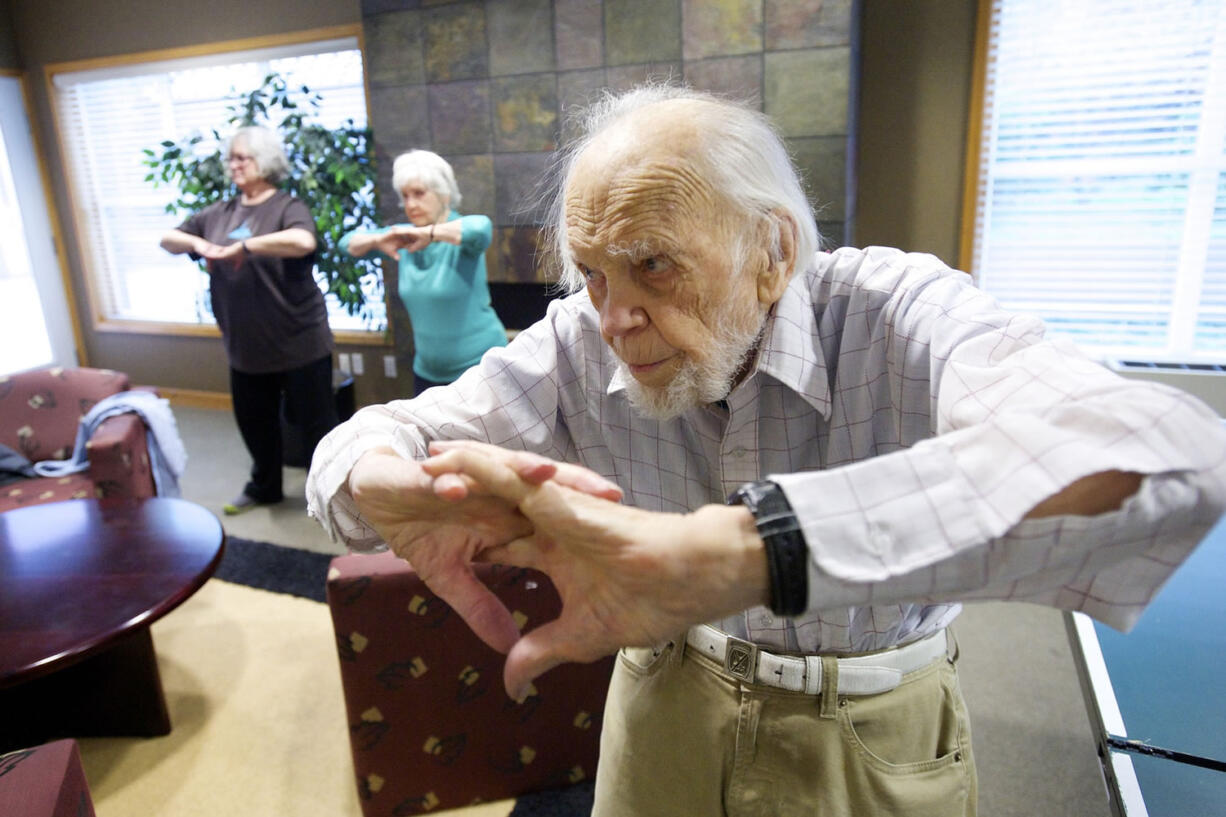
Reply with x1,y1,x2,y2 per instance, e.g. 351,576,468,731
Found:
34,391,188,497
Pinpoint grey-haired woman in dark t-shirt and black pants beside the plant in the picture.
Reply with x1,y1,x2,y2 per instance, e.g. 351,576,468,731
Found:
162,128,337,514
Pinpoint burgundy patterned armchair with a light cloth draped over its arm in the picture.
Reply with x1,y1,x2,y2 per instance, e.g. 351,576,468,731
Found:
0,368,157,512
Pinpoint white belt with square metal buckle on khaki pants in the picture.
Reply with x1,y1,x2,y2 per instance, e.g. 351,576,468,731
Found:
685,624,948,696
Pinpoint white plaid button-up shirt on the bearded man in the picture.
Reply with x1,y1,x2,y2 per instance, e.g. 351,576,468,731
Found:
308,248,1226,653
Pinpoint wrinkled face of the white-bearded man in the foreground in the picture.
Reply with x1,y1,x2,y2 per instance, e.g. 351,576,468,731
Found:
565,119,769,420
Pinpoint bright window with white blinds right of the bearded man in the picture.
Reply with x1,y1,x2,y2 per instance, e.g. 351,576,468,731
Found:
964,0,1226,363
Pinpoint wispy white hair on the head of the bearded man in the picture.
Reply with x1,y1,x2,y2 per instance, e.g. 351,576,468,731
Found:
546,83,821,292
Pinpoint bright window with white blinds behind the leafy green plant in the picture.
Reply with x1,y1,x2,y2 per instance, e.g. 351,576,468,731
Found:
49,31,386,331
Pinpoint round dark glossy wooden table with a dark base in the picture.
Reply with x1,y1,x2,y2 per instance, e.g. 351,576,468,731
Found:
0,498,224,748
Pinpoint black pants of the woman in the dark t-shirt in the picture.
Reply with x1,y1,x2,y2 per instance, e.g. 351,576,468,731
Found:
230,355,337,502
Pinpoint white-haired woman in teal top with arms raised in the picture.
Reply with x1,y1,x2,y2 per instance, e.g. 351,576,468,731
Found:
341,151,506,394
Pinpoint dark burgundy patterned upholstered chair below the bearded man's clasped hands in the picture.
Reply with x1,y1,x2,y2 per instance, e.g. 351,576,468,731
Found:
327,553,613,817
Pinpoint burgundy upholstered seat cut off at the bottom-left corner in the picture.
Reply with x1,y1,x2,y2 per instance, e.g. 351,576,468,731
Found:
0,740,93,817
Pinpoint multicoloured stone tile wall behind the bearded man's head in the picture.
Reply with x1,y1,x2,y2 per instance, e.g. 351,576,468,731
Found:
362,0,855,292
